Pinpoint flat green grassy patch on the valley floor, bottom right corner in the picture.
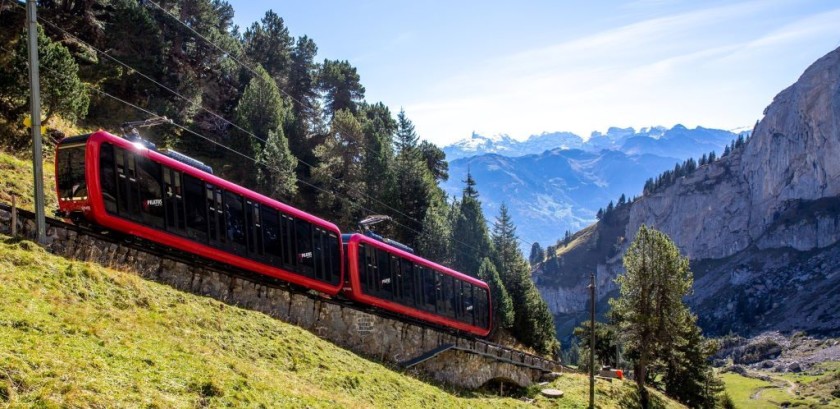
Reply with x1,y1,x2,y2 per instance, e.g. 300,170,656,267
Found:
721,362,840,408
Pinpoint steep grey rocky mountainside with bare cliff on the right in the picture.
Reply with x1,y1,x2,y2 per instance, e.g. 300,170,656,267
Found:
537,49,840,334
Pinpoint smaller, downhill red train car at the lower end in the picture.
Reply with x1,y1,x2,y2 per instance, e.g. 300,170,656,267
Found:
343,233,493,337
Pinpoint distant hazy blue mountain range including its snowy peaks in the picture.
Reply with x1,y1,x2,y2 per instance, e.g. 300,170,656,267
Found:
443,125,739,254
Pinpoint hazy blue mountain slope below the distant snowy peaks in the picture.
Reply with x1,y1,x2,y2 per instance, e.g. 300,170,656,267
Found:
443,149,677,250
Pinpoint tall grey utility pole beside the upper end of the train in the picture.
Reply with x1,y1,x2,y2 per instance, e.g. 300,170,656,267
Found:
26,0,47,244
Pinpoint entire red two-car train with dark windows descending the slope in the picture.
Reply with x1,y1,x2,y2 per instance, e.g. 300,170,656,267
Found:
55,131,492,336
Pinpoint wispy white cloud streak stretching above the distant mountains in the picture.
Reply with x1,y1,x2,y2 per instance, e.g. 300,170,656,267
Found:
405,1,840,144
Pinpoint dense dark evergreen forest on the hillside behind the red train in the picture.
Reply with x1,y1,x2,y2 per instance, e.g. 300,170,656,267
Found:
0,0,558,354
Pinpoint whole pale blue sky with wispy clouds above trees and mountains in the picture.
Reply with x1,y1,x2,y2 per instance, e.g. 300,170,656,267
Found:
229,0,840,146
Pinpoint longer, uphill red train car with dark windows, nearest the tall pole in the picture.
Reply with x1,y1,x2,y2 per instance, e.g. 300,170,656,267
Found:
55,130,344,296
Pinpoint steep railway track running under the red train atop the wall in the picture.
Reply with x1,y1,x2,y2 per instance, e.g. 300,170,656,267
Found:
0,203,564,372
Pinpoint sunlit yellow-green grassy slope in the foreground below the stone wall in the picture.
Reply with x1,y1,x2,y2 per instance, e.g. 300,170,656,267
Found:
0,236,679,408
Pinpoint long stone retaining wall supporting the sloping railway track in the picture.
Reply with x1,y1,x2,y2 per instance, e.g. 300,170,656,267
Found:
0,209,559,389
